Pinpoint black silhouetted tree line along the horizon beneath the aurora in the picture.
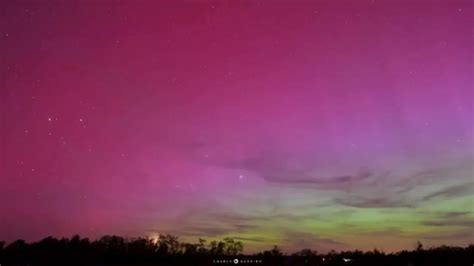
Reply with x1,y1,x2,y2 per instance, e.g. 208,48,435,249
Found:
0,235,474,266
